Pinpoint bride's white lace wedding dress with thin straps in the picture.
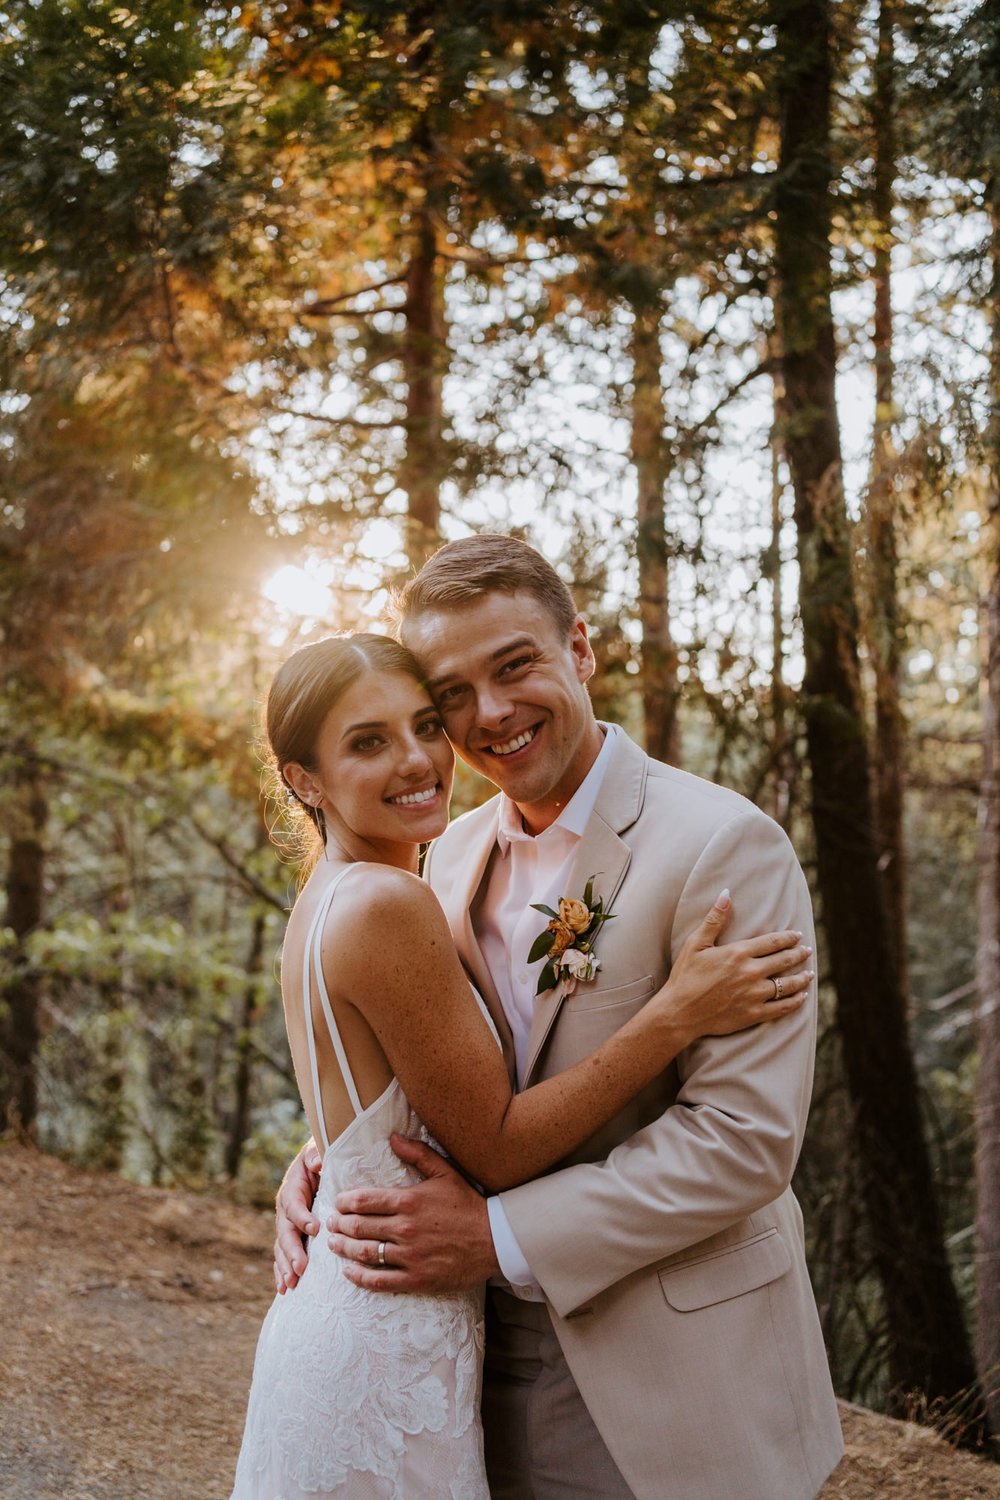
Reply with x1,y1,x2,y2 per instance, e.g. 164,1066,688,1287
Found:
232,866,489,1500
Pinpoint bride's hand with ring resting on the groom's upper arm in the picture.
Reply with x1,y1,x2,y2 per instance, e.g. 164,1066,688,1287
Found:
657,891,814,1041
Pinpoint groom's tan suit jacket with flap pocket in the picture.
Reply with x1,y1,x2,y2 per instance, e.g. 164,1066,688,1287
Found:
426,734,843,1500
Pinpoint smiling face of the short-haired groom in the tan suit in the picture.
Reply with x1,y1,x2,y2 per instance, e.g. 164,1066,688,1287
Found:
403,593,601,833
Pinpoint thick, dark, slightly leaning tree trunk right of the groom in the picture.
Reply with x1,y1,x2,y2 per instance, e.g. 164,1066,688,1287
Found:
775,0,976,1437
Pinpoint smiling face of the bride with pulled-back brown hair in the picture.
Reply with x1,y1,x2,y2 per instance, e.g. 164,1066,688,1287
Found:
296,672,454,854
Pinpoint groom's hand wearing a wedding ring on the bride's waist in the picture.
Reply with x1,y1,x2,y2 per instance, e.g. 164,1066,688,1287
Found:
327,1136,499,1293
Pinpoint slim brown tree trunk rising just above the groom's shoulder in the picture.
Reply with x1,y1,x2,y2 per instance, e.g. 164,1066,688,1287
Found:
630,303,681,765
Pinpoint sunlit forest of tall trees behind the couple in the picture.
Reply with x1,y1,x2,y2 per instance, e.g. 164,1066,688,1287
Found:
0,0,1000,1464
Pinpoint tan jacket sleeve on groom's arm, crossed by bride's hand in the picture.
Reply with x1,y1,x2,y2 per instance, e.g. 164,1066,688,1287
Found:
501,813,816,1316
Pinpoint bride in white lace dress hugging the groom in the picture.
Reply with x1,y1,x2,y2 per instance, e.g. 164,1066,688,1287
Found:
232,635,808,1500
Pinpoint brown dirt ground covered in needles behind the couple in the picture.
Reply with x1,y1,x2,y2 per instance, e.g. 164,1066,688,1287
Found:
0,1146,1000,1500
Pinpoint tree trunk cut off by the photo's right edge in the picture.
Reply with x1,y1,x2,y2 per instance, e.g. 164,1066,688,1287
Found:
976,199,1000,1437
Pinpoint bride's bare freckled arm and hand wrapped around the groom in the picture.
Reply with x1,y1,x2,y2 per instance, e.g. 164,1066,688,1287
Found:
332,867,810,1191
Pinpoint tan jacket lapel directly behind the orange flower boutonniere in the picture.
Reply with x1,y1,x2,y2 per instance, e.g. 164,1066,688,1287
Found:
522,731,646,1088
